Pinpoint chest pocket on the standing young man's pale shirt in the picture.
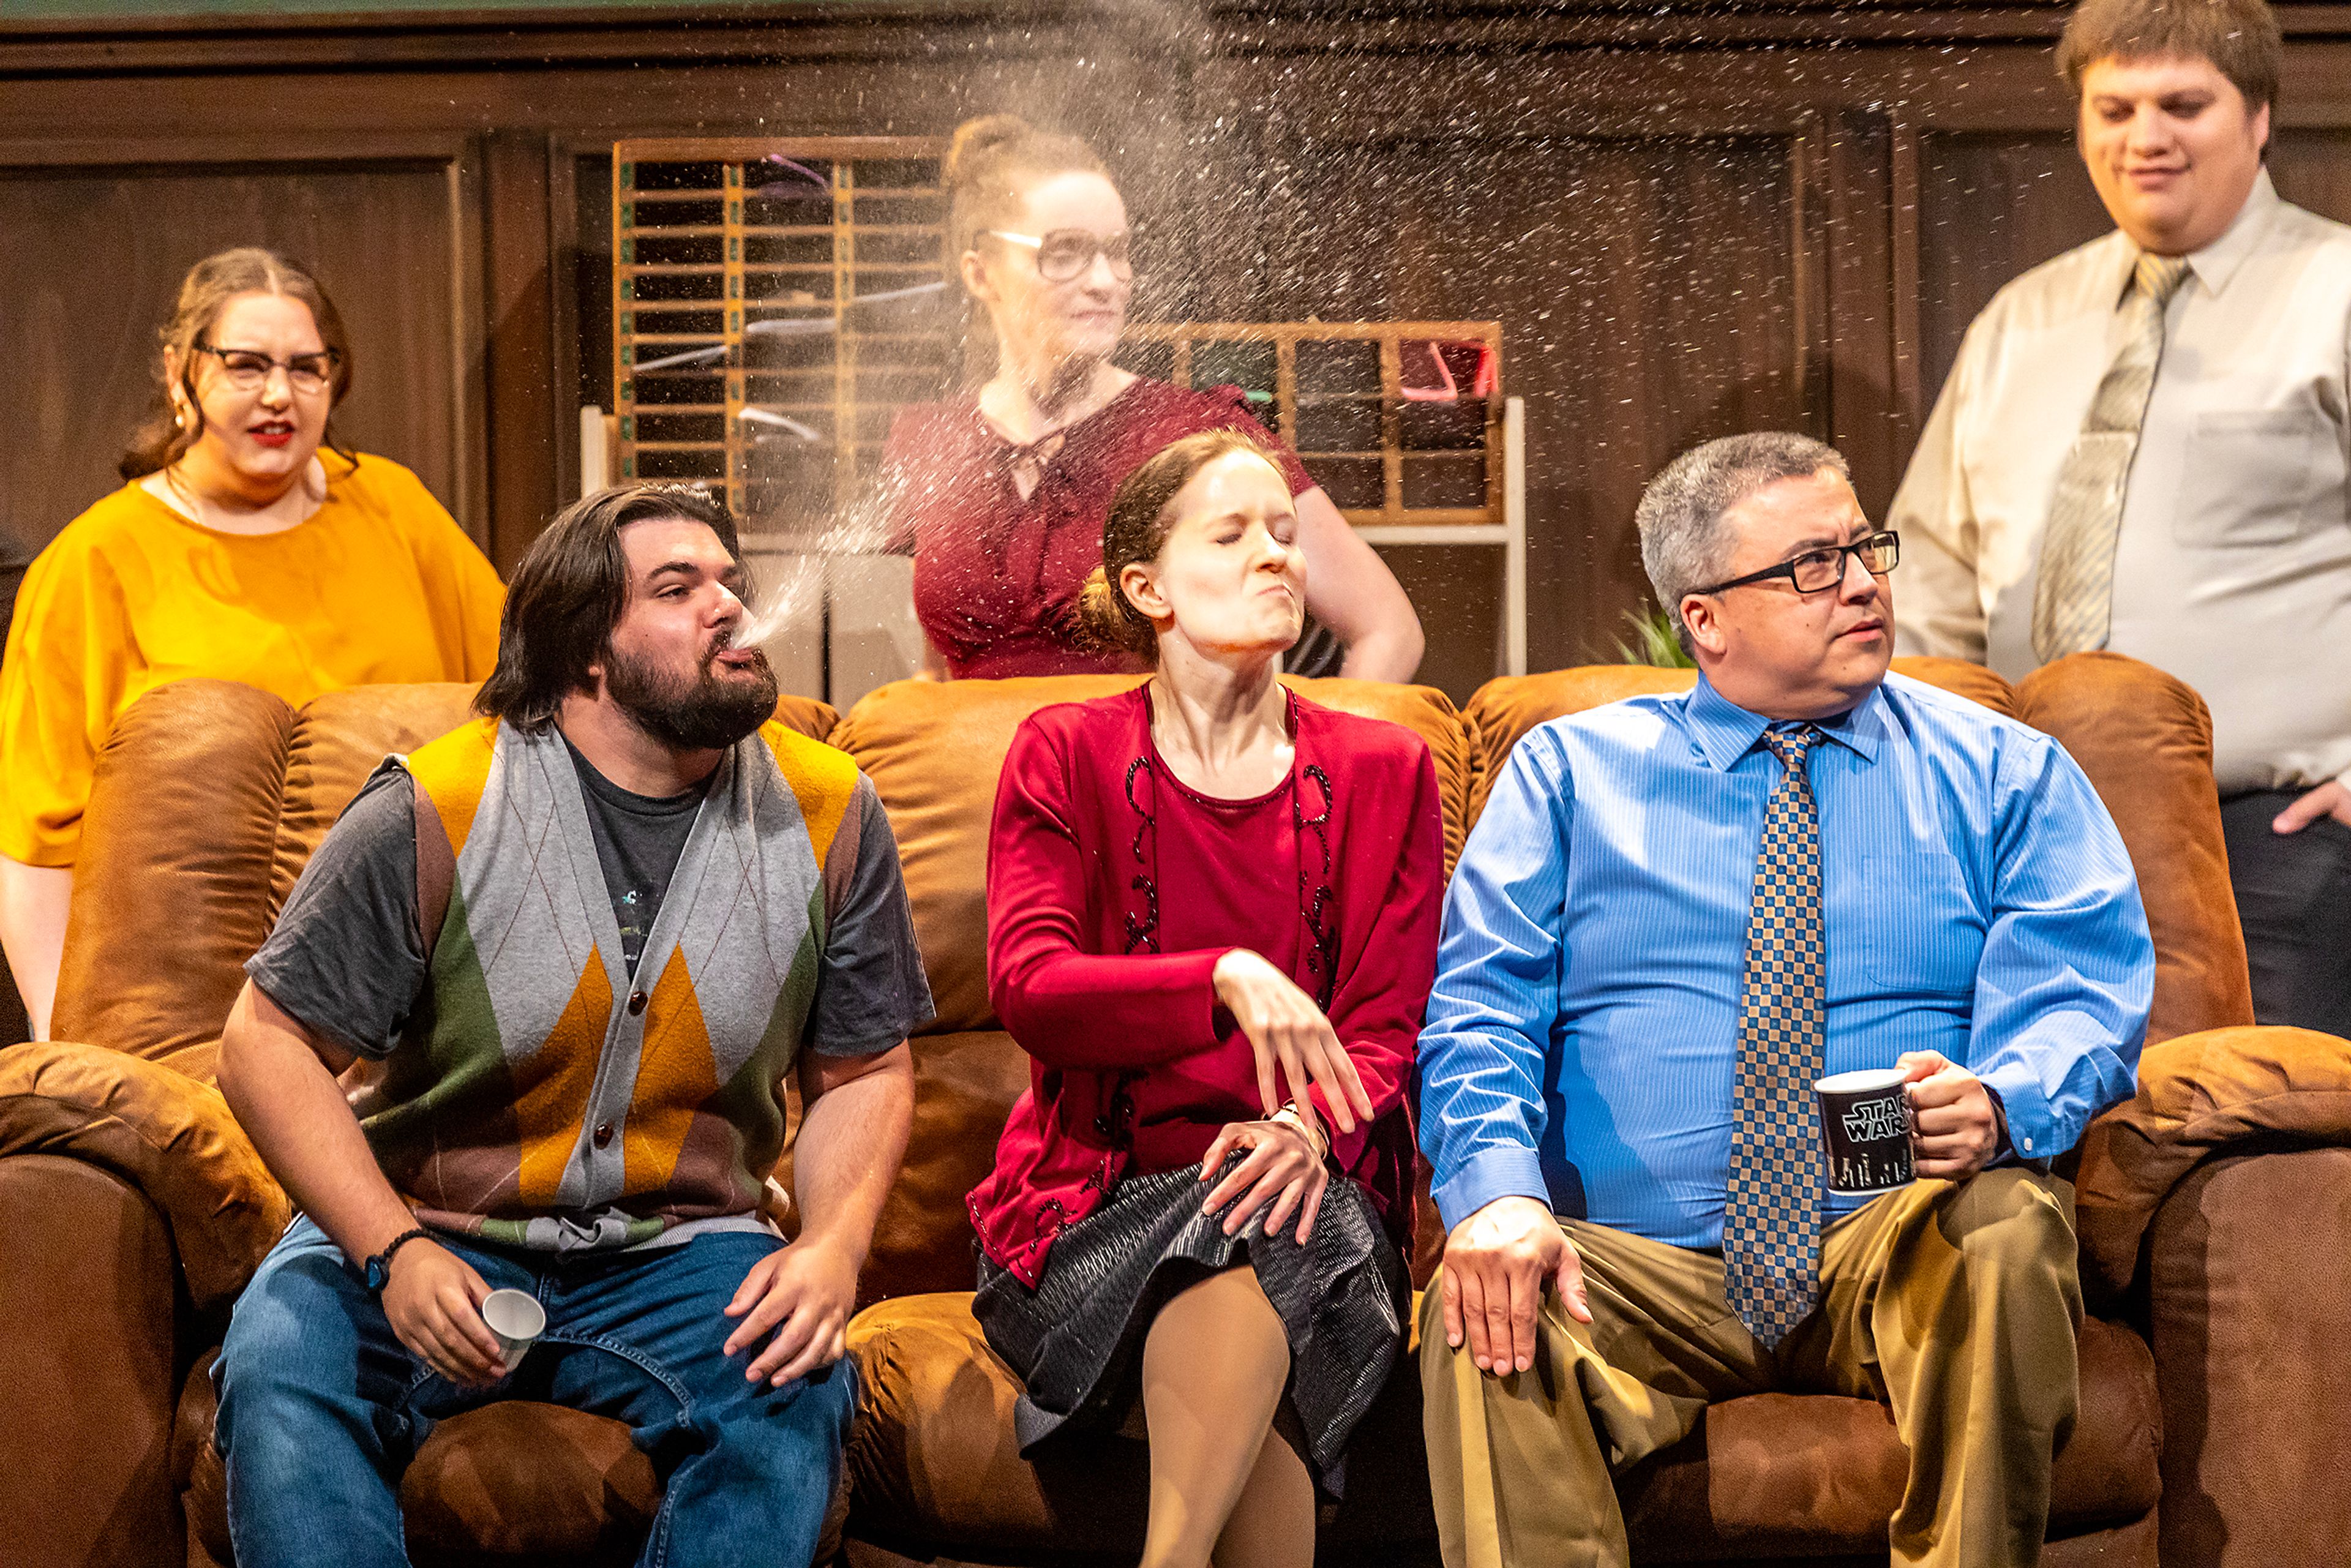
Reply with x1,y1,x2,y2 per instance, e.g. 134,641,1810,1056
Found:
2172,409,2344,548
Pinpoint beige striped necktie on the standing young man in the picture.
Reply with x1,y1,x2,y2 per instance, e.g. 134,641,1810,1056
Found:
2034,254,2189,663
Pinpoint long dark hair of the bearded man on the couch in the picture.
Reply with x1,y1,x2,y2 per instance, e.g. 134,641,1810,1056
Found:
473,484,743,731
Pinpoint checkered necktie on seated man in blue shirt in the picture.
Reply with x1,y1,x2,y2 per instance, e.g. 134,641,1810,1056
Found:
1723,724,1829,1349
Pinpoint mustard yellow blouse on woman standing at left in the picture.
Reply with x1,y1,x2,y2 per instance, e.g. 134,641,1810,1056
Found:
0,451,506,865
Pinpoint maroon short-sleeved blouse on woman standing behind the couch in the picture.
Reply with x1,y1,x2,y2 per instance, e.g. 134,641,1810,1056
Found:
882,376,1314,680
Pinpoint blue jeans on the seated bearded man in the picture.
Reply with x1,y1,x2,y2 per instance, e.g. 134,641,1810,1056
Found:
214,1218,856,1568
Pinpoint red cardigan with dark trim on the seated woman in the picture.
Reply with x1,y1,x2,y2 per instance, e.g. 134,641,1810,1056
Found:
971,686,1444,1286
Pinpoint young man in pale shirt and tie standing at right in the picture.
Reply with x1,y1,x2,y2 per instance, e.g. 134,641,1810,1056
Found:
1888,0,2351,1034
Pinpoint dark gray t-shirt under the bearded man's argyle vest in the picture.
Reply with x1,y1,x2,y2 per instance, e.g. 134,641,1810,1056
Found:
244,743,931,1058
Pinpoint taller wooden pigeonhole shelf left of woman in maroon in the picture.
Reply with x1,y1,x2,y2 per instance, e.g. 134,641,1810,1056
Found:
611,137,950,531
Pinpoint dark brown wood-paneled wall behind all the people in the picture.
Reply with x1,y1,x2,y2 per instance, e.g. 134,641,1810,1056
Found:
0,0,2351,694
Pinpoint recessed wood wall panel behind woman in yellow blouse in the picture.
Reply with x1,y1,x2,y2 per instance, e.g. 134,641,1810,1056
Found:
0,151,479,595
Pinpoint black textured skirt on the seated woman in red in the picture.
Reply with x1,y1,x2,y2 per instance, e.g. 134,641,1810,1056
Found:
971,1154,1411,1498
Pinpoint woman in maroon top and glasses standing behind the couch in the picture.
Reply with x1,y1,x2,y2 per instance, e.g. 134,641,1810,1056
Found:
882,115,1420,681
